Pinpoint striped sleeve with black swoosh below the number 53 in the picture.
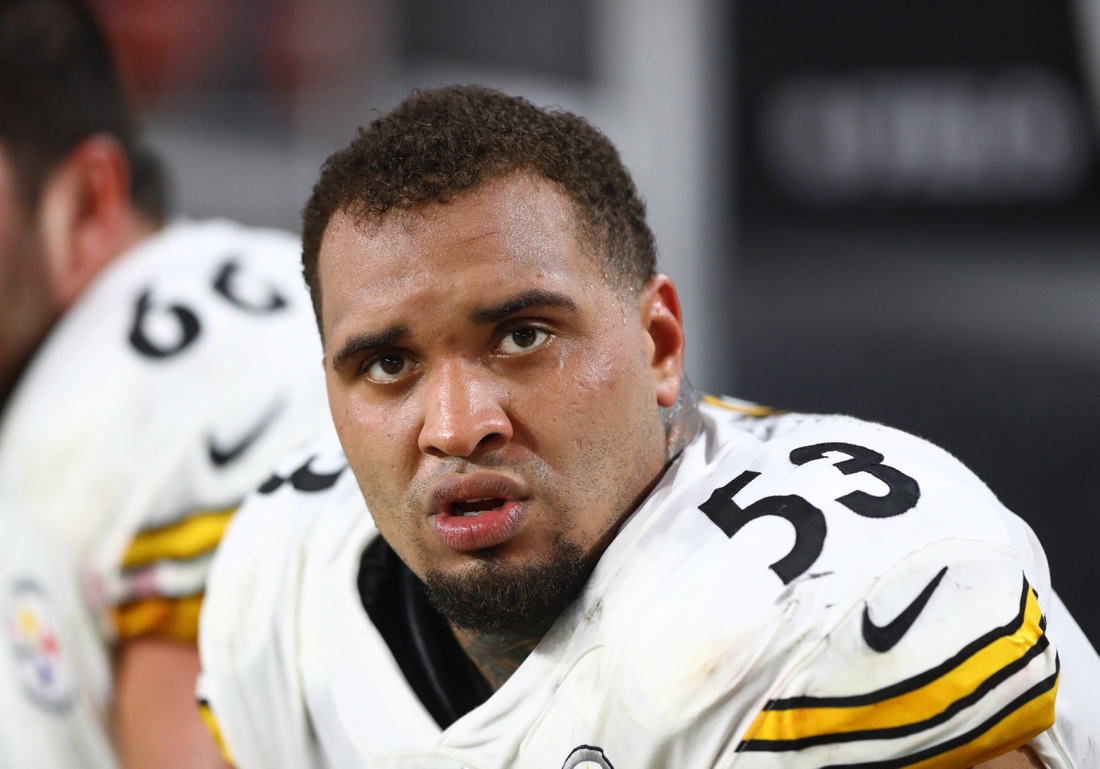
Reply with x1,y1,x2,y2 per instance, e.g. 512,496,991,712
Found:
732,540,1071,769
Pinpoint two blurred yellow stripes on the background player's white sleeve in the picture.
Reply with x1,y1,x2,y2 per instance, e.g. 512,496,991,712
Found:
113,507,237,644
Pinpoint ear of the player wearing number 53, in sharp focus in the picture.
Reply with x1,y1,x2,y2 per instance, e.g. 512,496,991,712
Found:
639,274,684,407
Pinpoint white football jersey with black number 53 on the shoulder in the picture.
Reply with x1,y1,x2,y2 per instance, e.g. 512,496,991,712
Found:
200,398,1097,769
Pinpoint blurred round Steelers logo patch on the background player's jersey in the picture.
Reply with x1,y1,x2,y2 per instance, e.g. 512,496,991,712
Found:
6,580,73,713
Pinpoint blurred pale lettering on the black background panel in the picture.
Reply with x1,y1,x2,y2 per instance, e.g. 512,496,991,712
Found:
758,68,1089,206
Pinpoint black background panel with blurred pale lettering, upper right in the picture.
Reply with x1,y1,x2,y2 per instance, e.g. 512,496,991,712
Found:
737,0,1100,220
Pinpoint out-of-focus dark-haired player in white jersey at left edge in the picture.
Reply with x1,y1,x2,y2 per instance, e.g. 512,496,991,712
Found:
0,0,328,769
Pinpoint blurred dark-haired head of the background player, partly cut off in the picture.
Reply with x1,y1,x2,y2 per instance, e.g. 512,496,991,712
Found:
0,0,165,404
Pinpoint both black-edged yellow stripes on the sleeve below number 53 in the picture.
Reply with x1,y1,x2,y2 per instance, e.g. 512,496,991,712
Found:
737,580,1058,769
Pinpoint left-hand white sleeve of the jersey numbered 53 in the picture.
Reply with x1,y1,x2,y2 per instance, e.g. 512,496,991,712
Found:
199,436,347,769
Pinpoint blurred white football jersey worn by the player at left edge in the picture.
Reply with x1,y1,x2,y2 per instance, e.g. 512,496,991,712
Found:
0,221,329,767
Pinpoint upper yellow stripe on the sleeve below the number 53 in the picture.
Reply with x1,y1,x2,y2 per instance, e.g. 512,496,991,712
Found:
747,590,1043,740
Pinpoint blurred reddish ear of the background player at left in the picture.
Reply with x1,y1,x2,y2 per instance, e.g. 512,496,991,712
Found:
37,134,130,307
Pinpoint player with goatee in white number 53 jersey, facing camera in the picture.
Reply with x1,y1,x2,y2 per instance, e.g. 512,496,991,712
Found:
200,87,1098,769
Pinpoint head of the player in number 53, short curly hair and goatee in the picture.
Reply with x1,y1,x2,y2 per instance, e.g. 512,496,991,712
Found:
305,88,683,634
